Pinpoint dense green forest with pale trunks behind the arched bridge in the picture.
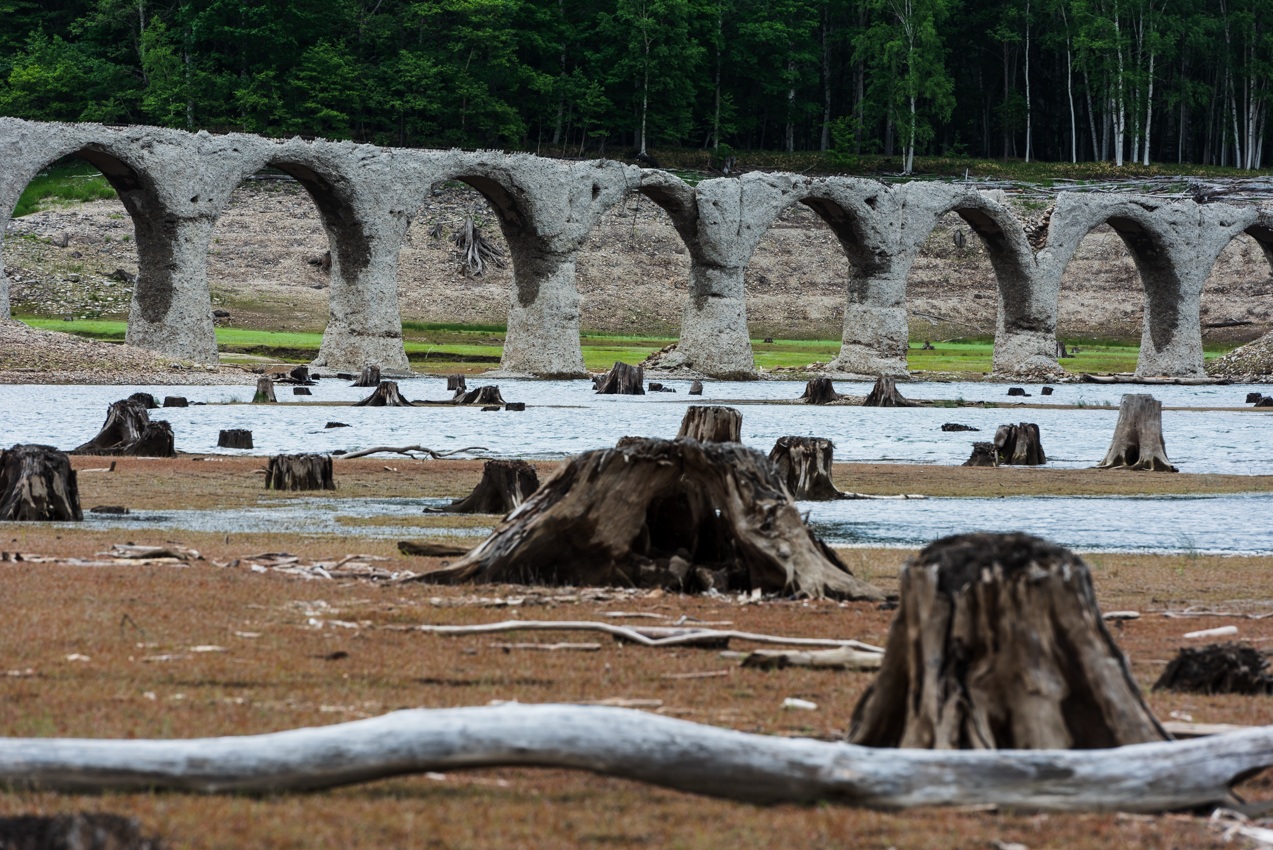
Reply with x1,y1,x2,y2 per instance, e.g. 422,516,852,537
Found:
0,0,1273,173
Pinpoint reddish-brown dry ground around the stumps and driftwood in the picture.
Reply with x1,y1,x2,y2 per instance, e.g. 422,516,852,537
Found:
0,457,1273,850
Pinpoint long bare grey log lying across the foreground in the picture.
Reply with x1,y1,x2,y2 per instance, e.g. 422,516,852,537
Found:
0,704,1273,812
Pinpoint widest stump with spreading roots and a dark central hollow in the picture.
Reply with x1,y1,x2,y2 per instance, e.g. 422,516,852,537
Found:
409,439,883,601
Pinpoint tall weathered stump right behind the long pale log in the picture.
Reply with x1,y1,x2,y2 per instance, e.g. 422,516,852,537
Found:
848,534,1170,749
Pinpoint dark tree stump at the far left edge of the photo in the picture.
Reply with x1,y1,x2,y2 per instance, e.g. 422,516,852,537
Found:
0,445,84,522
